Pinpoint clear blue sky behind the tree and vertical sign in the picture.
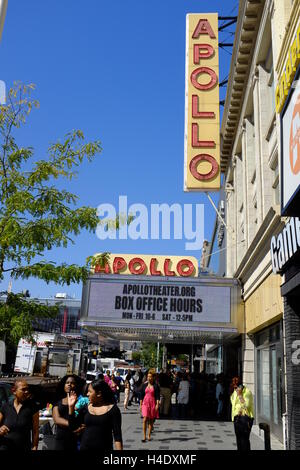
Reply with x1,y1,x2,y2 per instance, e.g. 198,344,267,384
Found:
0,0,238,297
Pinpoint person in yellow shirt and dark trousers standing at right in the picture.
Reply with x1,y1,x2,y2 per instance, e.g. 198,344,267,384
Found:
230,380,254,450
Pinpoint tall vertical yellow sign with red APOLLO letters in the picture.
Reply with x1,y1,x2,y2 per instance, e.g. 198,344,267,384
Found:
184,13,220,191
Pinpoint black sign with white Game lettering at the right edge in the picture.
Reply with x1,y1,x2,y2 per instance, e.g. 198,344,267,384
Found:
271,217,300,274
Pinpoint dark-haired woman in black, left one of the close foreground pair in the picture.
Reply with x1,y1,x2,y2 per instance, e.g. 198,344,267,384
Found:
52,374,84,452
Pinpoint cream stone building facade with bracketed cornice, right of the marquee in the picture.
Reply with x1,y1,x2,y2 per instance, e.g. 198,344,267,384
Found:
221,0,299,447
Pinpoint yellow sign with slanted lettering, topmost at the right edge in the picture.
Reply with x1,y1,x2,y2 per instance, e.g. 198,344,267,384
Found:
275,24,300,113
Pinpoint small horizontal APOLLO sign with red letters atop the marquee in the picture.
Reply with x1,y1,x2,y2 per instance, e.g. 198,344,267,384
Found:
92,253,198,277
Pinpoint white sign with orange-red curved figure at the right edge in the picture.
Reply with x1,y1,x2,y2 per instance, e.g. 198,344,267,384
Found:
281,68,300,216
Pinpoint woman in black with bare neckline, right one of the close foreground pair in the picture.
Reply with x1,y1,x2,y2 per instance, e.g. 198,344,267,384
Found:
68,380,123,453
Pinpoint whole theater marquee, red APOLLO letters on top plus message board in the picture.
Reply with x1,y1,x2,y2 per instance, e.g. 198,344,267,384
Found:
80,254,244,374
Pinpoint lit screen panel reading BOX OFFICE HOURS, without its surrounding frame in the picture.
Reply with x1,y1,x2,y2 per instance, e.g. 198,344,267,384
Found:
84,278,230,326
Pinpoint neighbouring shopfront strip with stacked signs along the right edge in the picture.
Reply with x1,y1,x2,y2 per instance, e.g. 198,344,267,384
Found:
270,1,300,450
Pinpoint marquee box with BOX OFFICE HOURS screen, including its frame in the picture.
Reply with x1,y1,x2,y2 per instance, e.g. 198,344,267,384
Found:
80,274,241,344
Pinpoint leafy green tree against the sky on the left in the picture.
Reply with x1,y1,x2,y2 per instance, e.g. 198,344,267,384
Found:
0,83,125,343
